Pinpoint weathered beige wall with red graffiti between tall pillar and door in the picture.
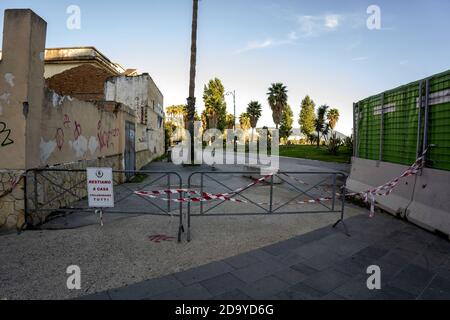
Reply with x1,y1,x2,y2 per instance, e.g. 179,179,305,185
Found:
39,91,134,166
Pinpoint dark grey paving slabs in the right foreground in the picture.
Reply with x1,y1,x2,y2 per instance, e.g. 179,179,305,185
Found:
84,214,450,300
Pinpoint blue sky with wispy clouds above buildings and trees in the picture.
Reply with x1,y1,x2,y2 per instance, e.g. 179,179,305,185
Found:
0,0,450,134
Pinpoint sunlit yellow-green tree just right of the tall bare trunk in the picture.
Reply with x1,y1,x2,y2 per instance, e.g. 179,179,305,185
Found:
203,78,227,131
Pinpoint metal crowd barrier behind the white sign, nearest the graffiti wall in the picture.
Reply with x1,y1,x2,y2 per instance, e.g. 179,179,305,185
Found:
25,168,184,241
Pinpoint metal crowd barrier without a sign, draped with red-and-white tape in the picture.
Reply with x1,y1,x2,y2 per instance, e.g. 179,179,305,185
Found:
187,171,348,241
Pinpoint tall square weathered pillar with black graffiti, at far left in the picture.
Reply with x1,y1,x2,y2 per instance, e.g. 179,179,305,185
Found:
0,10,47,229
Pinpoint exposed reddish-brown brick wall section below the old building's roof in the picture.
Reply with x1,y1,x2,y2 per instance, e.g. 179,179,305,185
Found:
46,64,113,101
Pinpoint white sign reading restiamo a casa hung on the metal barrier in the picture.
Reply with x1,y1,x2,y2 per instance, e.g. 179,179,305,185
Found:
86,168,114,208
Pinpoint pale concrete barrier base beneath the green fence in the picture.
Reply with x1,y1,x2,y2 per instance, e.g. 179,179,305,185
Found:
347,158,450,235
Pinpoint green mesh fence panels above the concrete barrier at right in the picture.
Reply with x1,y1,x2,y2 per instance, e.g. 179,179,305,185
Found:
356,71,450,170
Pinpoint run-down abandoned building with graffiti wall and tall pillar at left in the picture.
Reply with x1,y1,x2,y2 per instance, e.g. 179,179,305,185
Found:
0,9,164,229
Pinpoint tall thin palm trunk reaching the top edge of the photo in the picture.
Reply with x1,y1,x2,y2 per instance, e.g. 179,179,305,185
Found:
187,0,198,164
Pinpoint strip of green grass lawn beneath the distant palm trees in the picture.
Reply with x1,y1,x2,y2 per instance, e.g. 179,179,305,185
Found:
280,145,352,163
